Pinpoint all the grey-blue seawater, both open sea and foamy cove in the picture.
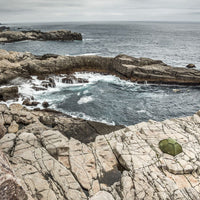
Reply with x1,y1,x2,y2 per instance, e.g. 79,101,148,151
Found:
0,22,200,125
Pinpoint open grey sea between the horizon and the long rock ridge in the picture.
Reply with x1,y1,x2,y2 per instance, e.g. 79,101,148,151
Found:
0,22,200,68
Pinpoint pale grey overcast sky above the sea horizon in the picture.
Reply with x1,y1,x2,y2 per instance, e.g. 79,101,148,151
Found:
0,0,200,23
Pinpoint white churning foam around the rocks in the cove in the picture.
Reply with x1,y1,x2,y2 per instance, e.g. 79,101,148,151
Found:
1,72,139,125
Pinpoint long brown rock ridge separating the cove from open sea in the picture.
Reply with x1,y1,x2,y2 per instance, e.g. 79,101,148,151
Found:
0,50,200,85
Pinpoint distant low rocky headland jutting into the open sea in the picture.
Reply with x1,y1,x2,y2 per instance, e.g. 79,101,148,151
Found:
0,30,82,42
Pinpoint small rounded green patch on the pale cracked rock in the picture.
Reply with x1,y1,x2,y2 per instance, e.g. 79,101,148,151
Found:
159,138,183,156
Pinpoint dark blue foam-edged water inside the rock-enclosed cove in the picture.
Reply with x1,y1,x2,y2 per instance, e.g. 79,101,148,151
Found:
7,73,200,125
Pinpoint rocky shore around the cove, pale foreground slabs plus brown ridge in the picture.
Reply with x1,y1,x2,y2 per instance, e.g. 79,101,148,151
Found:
0,50,200,200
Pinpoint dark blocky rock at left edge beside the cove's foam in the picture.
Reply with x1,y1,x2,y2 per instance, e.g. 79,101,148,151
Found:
0,86,19,101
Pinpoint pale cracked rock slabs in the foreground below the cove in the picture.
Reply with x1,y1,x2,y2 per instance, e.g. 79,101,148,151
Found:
0,104,200,200
